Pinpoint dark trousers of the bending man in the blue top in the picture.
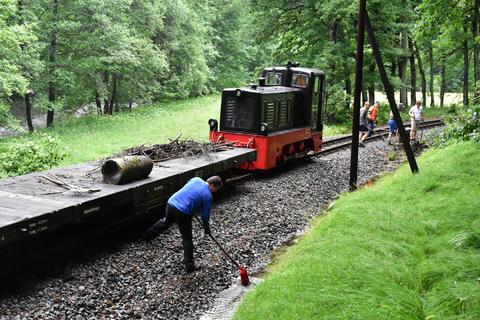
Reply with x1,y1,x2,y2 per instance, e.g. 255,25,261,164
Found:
147,204,193,269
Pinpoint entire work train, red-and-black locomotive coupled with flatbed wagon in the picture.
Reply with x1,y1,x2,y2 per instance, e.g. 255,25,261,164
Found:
0,63,325,272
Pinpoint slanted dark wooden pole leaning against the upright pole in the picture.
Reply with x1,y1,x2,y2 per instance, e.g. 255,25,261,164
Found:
365,11,418,173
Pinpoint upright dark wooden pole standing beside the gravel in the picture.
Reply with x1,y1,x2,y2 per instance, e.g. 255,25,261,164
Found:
349,0,367,191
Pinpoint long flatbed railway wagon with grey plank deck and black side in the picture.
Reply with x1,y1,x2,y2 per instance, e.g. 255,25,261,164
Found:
0,148,256,270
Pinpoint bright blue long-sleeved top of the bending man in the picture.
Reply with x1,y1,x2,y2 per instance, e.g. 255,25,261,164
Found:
168,177,213,223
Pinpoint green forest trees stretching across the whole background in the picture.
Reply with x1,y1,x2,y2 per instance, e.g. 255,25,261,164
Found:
0,0,480,130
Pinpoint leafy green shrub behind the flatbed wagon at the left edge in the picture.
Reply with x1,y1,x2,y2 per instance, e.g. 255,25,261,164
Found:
0,134,66,177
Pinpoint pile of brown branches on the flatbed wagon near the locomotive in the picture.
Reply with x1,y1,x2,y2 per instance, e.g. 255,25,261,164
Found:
119,136,233,162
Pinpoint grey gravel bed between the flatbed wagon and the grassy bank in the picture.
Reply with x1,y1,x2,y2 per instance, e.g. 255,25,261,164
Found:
0,140,412,319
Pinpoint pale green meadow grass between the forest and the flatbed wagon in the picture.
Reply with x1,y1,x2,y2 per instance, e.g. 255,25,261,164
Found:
0,95,220,165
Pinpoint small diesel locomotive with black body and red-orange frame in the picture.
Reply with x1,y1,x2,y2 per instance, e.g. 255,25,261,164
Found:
208,62,325,170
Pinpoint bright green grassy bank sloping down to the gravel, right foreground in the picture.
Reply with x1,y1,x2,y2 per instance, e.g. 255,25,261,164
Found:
234,143,480,320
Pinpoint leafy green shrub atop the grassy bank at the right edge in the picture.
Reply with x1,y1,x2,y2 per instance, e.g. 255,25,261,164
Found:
433,106,480,148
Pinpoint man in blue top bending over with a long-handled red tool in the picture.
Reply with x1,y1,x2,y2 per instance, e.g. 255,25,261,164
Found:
142,176,223,272
